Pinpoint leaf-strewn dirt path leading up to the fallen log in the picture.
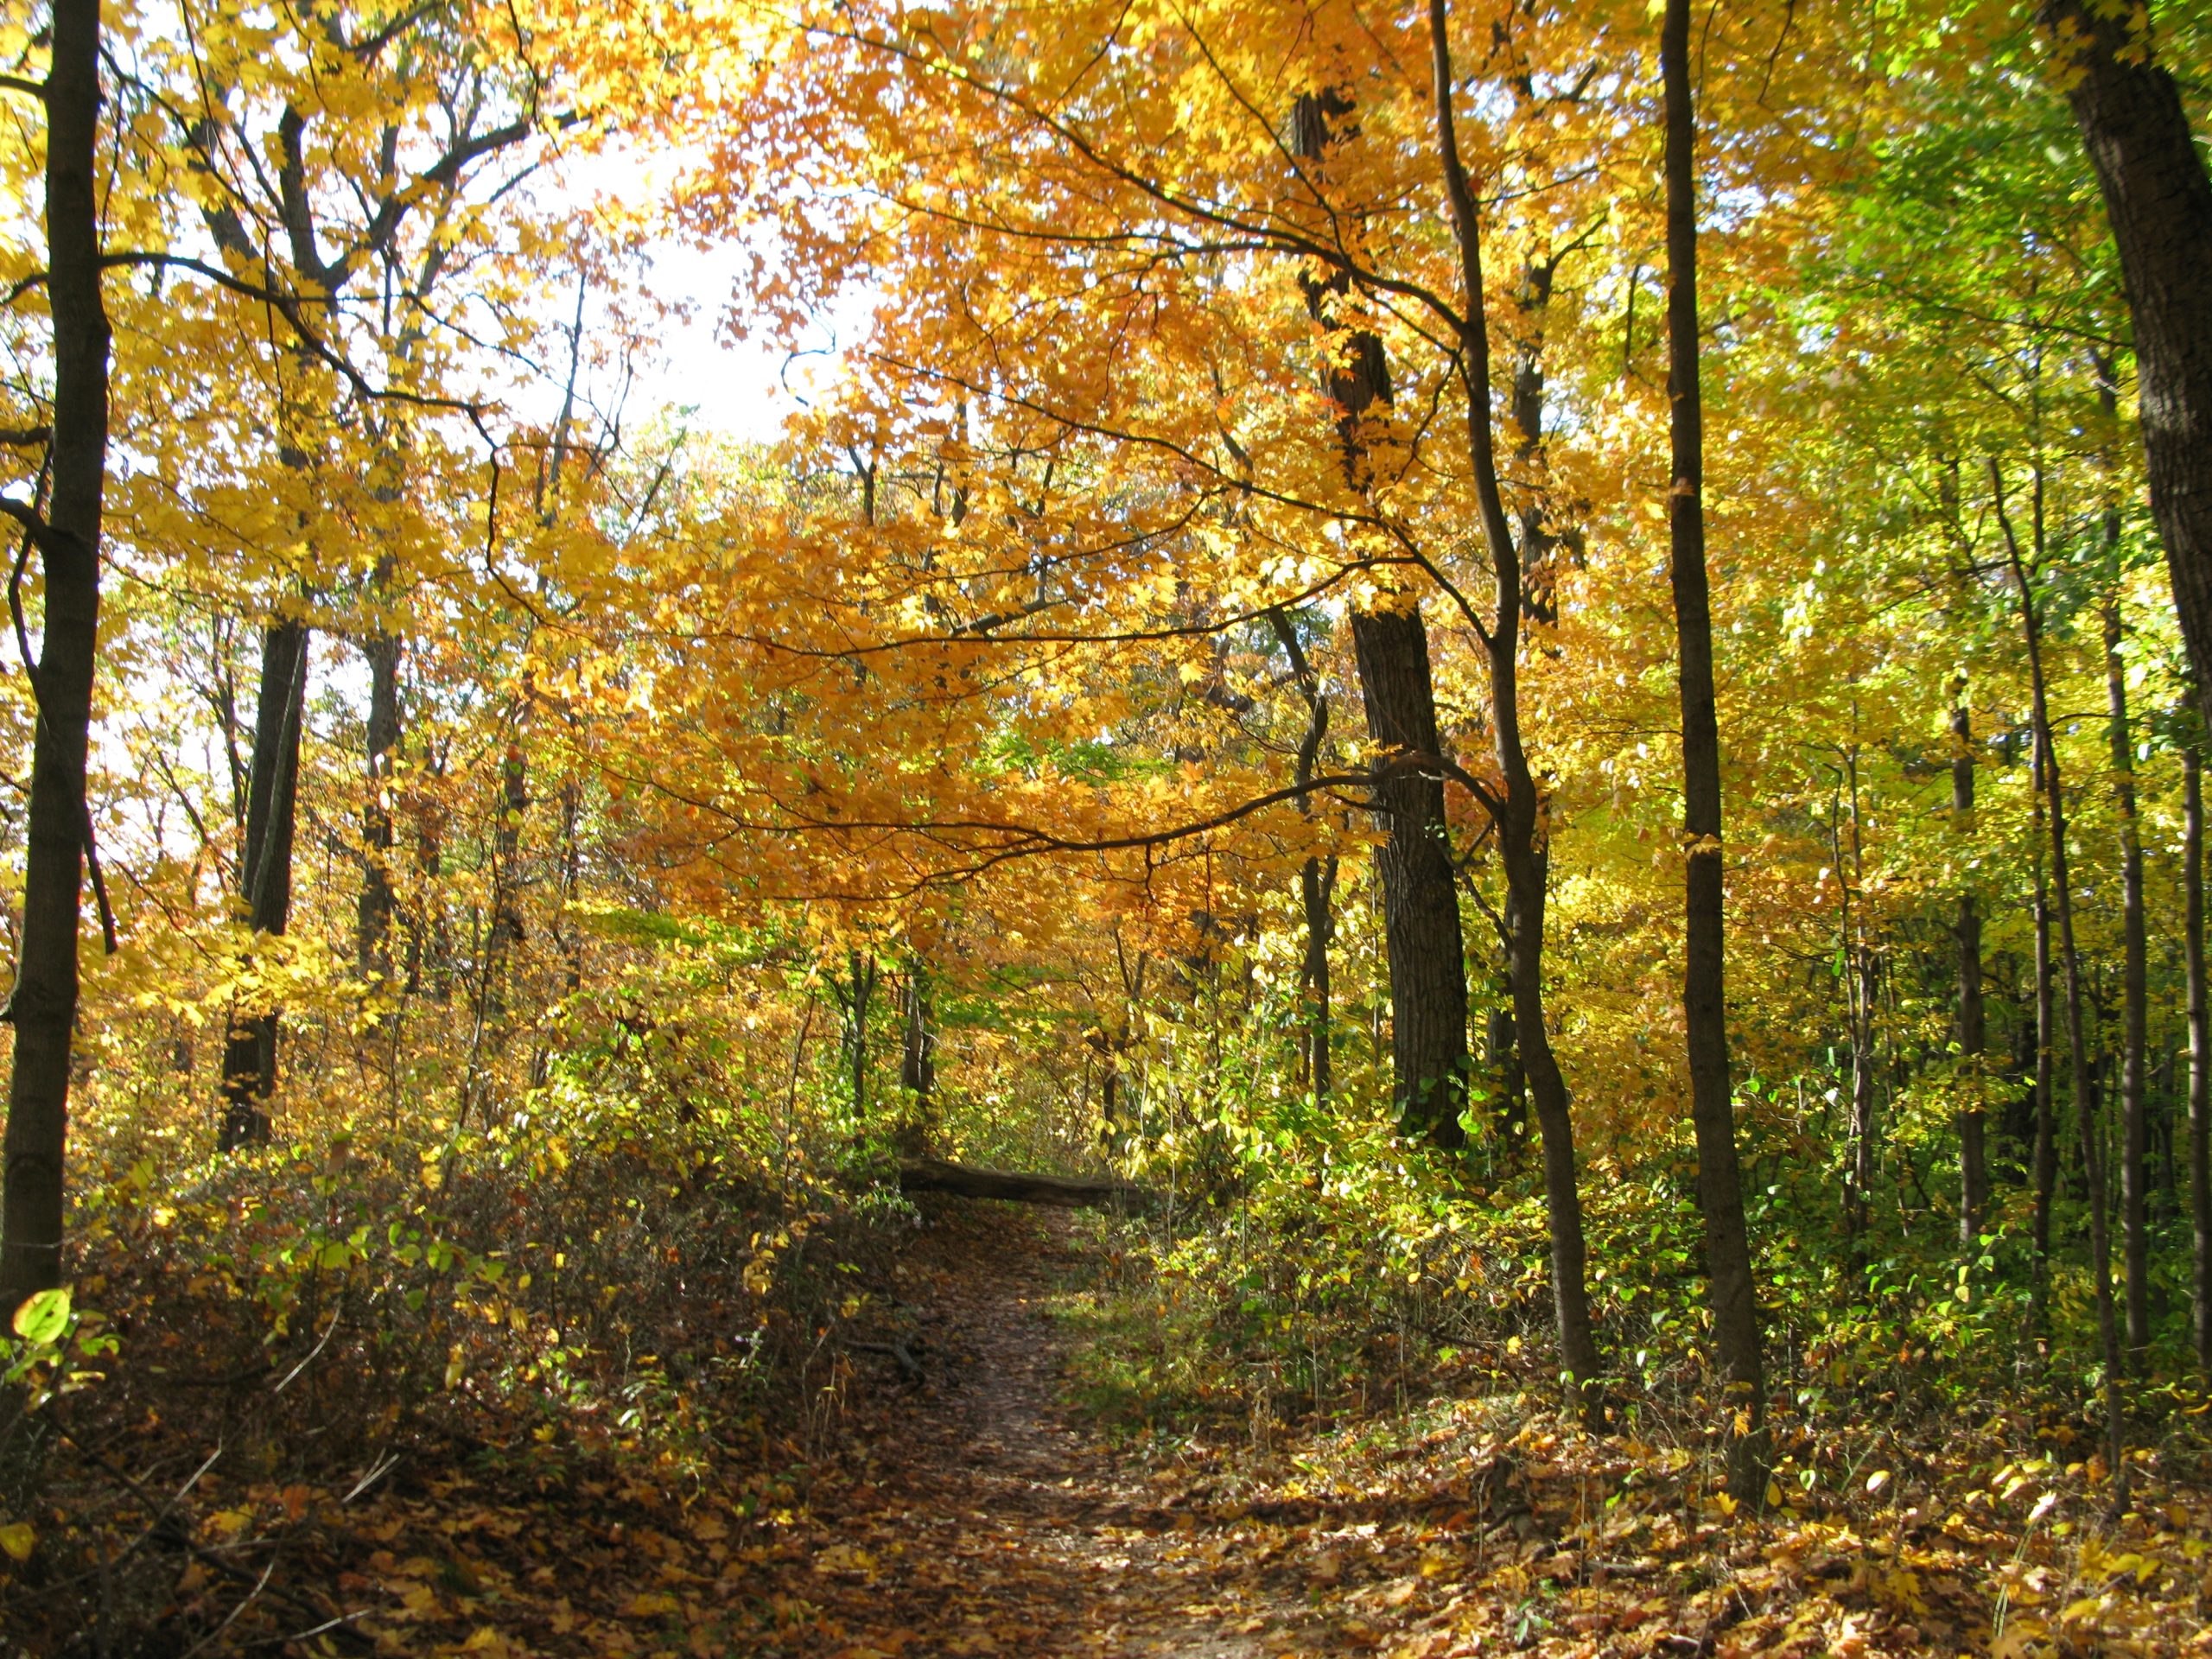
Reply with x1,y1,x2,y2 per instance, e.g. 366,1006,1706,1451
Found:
791,1217,1314,1659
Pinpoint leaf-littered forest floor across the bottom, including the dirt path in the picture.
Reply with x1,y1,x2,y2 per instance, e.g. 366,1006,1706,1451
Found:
99,1204,2212,1659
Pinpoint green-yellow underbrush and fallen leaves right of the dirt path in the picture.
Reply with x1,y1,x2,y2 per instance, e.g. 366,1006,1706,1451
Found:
1062,1096,2212,1655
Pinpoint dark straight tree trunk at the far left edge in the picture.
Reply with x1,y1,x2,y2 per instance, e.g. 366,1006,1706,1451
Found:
0,0,108,1307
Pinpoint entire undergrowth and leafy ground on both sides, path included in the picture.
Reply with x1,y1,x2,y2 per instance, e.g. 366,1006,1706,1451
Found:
0,1065,2212,1659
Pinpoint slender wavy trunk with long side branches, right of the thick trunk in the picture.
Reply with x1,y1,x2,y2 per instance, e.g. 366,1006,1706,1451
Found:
1429,0,1604,1425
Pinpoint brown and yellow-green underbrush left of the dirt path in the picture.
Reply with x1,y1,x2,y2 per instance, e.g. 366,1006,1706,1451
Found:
0,1082,912,1656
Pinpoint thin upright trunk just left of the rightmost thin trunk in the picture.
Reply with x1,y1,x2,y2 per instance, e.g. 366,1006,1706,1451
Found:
2104,593,2150,1360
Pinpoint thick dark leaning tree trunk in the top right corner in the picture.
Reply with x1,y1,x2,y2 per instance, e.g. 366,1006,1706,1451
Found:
2042,0,2212,739
